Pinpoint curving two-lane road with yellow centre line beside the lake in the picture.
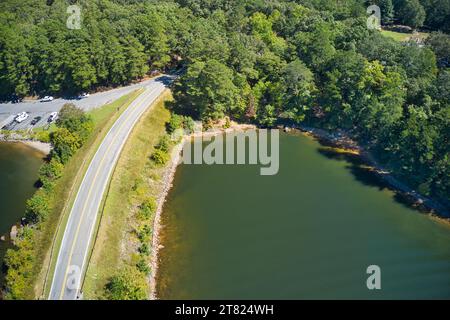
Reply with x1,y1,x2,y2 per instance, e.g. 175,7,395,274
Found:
49,76,168,300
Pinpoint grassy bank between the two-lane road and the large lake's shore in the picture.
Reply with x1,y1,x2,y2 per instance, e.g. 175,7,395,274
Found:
83,93,171,299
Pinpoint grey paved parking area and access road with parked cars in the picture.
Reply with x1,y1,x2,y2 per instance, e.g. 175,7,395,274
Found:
0,80,157,130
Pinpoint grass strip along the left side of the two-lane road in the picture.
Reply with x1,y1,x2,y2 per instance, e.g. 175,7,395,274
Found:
35,90,142,298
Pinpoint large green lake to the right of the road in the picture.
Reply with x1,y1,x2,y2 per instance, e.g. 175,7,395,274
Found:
157,134,450,299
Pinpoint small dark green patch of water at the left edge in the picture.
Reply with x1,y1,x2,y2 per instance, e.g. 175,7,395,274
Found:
0,142,43,283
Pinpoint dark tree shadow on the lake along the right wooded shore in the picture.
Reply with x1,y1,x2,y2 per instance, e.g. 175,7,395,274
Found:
318,146,430,213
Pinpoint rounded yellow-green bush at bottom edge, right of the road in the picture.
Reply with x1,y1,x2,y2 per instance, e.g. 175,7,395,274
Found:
106,267,148,300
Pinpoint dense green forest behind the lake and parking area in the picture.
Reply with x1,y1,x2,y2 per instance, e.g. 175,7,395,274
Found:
0,0,450,204
